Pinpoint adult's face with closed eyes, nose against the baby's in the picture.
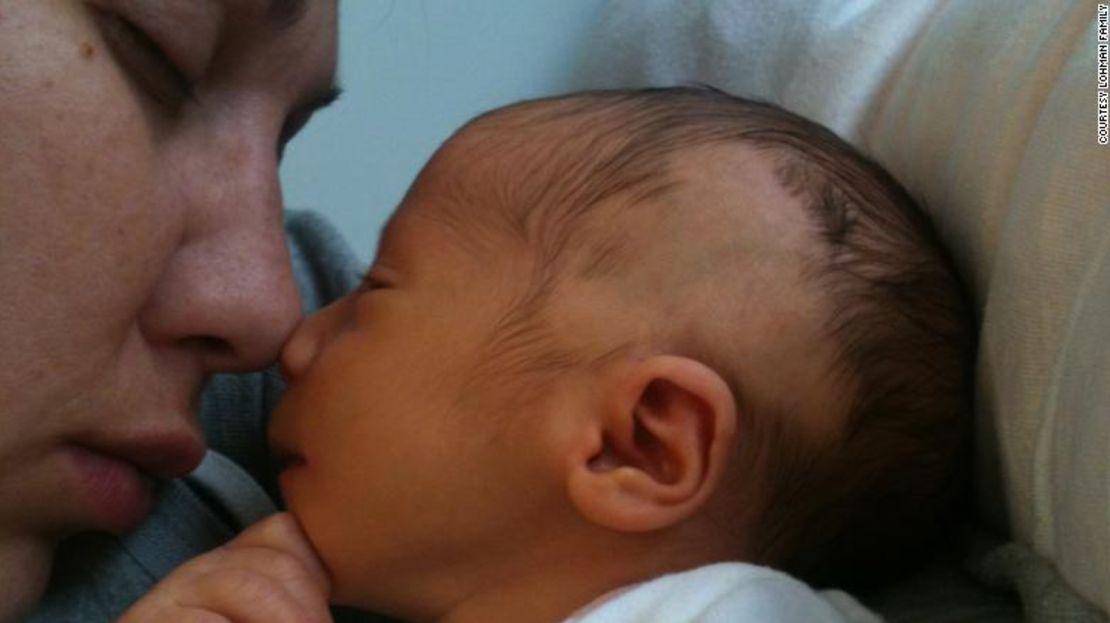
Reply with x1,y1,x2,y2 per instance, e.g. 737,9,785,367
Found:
0,0,336,620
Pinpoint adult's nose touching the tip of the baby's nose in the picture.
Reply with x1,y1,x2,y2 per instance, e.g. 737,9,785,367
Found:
141,123,302,372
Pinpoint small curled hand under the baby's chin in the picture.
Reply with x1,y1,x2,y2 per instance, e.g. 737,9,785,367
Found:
120,513,332,623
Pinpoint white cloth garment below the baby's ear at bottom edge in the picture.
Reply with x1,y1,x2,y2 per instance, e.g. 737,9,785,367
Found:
565,562,881,623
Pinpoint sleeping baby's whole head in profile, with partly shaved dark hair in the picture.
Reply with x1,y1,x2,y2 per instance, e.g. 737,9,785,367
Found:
271,88,973,619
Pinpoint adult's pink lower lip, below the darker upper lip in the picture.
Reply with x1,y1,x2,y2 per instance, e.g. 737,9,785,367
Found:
68,445,151,534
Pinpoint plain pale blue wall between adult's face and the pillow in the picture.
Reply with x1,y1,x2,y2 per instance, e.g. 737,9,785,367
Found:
282,0,603,261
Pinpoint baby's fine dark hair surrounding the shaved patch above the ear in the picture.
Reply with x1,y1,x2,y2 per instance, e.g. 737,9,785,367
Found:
437,87,976,590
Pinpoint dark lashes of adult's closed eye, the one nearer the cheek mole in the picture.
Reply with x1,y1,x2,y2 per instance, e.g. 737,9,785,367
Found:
95,10,193,112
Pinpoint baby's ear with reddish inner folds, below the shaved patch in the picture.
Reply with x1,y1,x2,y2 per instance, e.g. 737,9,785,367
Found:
567,355,736,532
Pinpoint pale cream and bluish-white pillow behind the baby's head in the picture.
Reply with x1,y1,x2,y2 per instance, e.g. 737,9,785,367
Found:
582,0,1110,611
